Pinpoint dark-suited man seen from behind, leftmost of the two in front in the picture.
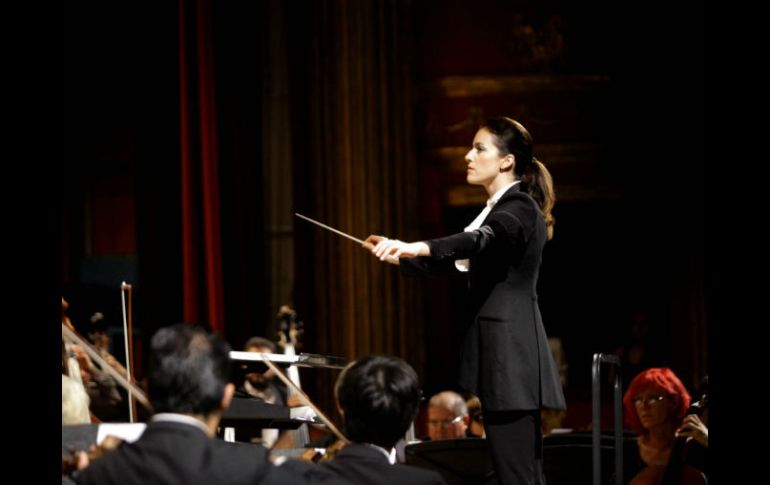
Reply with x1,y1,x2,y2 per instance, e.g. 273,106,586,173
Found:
74,324,338,485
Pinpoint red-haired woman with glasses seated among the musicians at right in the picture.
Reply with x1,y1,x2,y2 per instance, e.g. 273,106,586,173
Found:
623,367,705,485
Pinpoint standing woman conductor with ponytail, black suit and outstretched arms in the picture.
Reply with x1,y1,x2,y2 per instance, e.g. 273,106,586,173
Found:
364,117,566,484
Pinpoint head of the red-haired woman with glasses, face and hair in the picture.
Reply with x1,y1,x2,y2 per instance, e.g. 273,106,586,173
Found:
623,367,691,434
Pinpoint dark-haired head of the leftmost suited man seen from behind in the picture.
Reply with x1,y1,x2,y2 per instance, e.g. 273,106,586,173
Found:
148,323,234,417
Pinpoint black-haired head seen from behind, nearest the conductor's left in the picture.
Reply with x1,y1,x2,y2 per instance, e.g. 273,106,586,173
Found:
334,355,421,448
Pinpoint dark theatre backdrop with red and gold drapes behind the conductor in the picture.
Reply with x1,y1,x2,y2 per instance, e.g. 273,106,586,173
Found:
60,0,710,427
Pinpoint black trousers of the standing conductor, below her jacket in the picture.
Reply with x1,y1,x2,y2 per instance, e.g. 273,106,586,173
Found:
484,410,545,485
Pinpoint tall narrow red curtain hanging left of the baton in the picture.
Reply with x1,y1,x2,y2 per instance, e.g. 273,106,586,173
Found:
179,0,224,334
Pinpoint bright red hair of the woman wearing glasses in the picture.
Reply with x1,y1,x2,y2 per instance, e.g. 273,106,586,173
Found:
623,367,692,434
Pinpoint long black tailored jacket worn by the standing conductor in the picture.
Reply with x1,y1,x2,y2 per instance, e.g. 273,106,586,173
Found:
401,183,566,411
